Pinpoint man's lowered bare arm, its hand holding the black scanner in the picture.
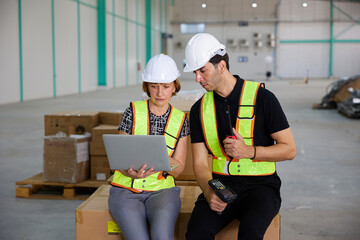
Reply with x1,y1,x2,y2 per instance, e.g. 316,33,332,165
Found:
191,142,227,212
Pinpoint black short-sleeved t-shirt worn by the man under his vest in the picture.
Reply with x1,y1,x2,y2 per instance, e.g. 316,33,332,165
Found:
190,75,289,189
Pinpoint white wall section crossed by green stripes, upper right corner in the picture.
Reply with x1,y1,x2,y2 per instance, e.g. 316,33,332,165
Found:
276,0,360,78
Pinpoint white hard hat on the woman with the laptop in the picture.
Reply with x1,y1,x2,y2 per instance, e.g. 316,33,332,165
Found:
142,54,180,83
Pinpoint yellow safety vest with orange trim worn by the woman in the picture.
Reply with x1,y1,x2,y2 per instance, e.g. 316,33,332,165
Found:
111,101,185,193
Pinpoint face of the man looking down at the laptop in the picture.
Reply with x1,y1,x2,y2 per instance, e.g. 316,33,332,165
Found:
194,62,221,92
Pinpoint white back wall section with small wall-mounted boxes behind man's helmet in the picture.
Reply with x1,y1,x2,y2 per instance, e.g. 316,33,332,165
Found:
172,23,274,80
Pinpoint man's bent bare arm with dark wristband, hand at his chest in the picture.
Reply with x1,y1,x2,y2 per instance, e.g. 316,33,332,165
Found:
224,128,296,162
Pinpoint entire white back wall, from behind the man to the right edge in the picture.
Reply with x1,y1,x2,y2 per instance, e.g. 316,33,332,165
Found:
171,0,360,80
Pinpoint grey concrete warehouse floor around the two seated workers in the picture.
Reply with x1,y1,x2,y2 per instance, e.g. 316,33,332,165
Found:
0,79,360,240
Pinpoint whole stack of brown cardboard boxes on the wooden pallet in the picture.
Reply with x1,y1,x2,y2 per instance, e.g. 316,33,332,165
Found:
43,111,122,183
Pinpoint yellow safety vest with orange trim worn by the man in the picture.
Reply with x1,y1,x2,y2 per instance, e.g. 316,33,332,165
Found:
201,81,275,176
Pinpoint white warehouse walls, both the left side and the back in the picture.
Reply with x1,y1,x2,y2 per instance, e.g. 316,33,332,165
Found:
0,0,360,104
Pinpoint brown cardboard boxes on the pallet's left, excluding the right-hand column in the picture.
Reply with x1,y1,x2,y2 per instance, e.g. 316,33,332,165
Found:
43,111,99,183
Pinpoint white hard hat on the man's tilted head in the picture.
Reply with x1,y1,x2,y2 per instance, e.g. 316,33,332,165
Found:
184,33,226,72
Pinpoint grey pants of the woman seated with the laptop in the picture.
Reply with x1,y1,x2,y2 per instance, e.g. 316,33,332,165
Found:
108,187,181,240
